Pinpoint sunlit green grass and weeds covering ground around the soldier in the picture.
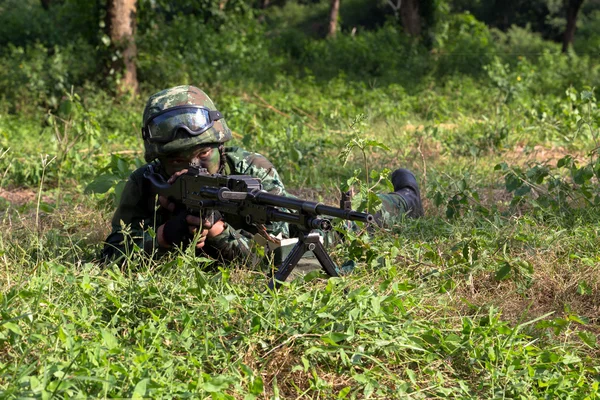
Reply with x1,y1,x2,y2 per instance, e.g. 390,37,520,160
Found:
0,74,600,399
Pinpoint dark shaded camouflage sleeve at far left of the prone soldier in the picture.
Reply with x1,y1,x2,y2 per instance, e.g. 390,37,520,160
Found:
102,169,165,261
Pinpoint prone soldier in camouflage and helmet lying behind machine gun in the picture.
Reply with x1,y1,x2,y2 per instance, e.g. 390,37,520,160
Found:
102,86,423,261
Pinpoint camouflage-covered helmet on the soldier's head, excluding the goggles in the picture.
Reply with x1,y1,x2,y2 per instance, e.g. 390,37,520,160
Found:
142,85,232,162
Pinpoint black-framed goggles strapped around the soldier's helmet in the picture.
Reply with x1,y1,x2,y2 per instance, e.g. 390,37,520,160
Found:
142,105,223,143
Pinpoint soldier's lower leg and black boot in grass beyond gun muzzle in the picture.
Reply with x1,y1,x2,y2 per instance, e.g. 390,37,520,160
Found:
375,168,423,227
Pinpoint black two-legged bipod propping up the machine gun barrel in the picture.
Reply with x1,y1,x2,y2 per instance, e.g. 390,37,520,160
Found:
269,233,340,289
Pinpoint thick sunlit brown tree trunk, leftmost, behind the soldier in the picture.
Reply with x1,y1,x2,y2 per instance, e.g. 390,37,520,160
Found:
106,0,138,95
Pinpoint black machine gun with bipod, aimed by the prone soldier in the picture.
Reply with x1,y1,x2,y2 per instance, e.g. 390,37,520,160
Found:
144,166,373,289
